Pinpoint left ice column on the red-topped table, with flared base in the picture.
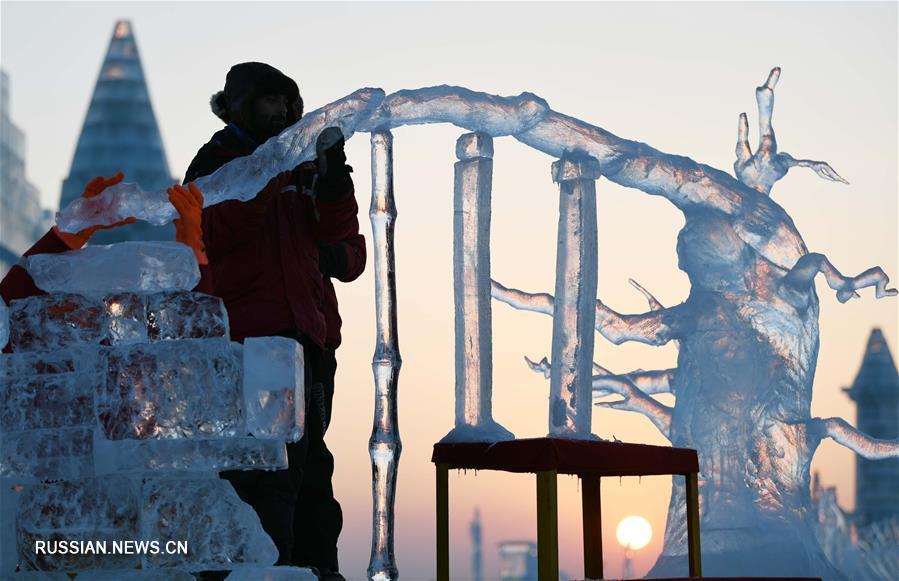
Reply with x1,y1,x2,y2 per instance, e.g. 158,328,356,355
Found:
443,133,514,441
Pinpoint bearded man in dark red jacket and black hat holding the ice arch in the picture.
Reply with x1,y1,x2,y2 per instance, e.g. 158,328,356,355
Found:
185,62,365,579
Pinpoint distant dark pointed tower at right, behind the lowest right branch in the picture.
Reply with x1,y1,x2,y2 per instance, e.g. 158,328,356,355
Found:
843,329,899,527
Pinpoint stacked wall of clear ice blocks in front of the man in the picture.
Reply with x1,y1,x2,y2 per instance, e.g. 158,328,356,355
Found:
0,242,314,579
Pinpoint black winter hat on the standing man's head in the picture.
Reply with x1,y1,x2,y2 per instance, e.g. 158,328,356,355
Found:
209,62,303,125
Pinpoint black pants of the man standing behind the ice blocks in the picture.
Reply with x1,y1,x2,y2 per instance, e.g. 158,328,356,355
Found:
221,337,343,571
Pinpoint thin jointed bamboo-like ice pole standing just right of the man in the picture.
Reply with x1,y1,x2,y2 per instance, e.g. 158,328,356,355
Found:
368,131,403,581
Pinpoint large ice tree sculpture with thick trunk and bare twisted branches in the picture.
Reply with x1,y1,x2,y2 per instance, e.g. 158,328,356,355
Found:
494,68,899,578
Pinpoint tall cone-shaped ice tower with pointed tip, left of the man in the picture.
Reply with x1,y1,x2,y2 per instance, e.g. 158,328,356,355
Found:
60,20,175,244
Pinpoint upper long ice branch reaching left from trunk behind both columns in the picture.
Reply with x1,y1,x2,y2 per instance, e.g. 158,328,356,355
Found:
491,280,674,346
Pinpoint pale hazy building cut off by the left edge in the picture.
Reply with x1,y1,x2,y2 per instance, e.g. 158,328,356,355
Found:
0,71,50,277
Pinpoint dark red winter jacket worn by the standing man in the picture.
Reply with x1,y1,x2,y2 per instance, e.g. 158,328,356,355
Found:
184,127,365,348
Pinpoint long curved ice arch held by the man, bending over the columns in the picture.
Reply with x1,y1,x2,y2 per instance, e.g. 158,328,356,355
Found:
58,85,808,269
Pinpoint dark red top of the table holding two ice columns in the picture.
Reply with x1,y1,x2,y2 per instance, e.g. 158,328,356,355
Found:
431,438,699,476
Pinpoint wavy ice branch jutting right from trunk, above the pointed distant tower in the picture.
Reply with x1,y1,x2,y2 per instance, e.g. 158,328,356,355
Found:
781,252,899,303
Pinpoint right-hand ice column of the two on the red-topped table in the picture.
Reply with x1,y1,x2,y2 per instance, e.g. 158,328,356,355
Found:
549,156,600,438
